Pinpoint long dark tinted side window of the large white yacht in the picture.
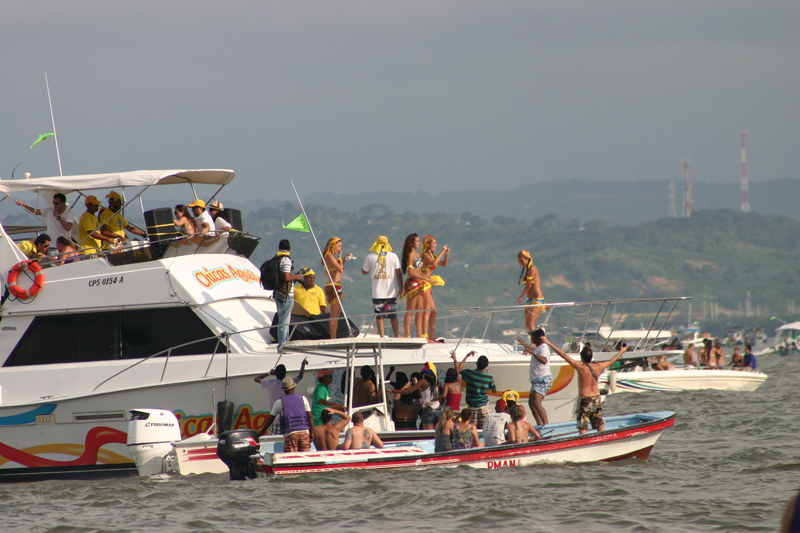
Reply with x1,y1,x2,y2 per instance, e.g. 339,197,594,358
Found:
3,307,219,366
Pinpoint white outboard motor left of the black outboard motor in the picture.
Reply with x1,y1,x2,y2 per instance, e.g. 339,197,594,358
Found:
128,409,181,476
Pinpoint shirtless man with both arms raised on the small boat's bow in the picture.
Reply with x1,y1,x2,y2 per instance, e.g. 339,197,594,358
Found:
542,336,628,435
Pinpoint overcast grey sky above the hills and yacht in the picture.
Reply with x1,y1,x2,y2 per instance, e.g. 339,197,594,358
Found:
0,0,800,200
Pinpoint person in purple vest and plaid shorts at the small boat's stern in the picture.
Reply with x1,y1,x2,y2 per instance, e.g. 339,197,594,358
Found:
258,377,314,452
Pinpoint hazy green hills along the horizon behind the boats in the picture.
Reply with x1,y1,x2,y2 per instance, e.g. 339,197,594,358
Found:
245,203,800,336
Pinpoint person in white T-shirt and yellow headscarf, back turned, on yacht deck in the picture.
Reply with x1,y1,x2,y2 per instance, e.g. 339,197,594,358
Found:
361,235,403,337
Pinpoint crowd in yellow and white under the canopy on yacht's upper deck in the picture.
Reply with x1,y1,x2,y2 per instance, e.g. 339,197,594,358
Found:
15,191,232,267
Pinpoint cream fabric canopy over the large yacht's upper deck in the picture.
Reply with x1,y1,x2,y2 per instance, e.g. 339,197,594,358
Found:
0,169,236,194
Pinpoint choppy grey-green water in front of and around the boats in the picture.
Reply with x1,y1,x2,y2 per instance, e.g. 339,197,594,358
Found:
0,356,800,533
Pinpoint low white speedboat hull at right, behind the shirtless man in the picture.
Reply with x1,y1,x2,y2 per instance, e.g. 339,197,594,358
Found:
599,367,767,394
